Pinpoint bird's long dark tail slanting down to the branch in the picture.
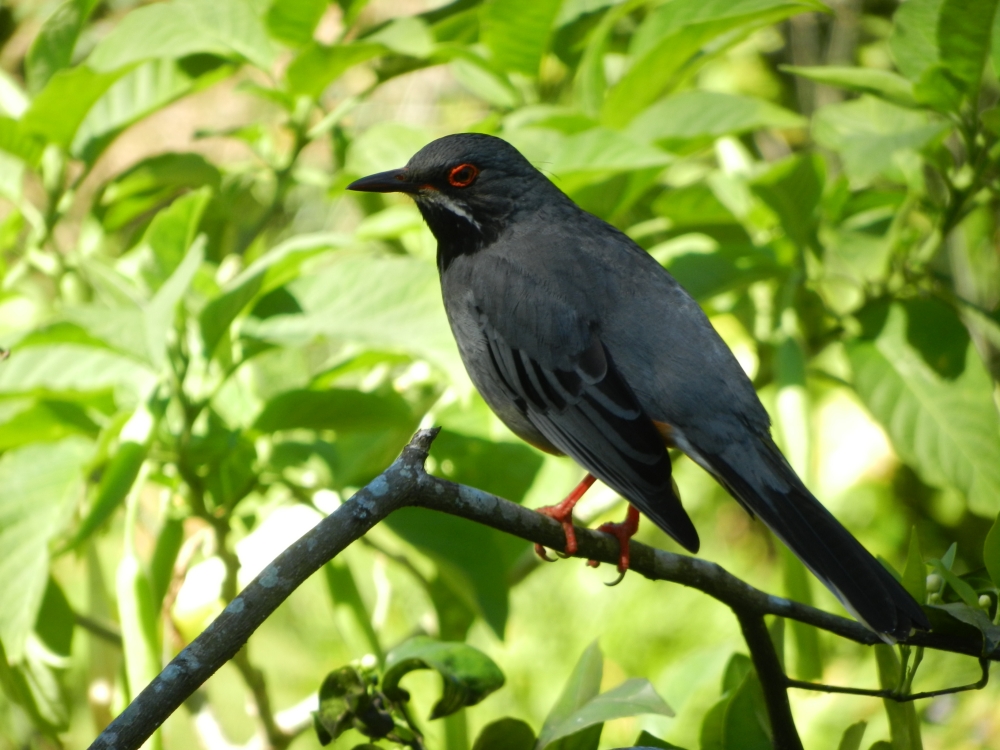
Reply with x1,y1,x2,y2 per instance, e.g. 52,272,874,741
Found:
704,438,930,642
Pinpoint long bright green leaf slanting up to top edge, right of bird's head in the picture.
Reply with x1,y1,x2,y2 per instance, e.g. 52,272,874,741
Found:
601,0,826,127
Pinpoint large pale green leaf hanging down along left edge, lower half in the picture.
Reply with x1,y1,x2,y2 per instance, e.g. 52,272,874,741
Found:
0,438,92,663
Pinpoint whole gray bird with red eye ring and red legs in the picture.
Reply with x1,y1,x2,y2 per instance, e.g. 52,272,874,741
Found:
347,133,930,643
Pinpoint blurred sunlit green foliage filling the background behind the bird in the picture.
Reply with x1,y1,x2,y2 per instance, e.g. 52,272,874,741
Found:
0,0,1000,750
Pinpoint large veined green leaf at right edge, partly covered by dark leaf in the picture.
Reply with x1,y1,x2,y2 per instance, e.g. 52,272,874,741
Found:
848,305,1000,515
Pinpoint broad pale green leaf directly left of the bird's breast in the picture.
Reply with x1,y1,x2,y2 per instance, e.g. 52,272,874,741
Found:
243,253,468,384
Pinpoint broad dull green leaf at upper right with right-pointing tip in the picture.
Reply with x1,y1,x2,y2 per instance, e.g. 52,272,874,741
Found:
813,96,950,184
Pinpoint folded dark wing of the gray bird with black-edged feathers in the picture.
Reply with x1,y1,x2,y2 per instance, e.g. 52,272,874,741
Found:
477,302,699,552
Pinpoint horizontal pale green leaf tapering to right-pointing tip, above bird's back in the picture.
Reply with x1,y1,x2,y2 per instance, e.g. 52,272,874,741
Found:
625,91,806,142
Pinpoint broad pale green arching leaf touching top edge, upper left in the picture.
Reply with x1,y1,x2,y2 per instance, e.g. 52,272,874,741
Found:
86,0,275,72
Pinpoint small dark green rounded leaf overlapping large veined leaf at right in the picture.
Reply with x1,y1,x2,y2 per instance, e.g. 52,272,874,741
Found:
902,298,969,380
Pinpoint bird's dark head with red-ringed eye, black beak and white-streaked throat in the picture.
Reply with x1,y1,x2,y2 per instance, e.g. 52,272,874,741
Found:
347,133,553,266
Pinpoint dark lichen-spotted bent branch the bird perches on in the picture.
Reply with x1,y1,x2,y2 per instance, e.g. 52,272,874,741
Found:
90,429,1000,750
